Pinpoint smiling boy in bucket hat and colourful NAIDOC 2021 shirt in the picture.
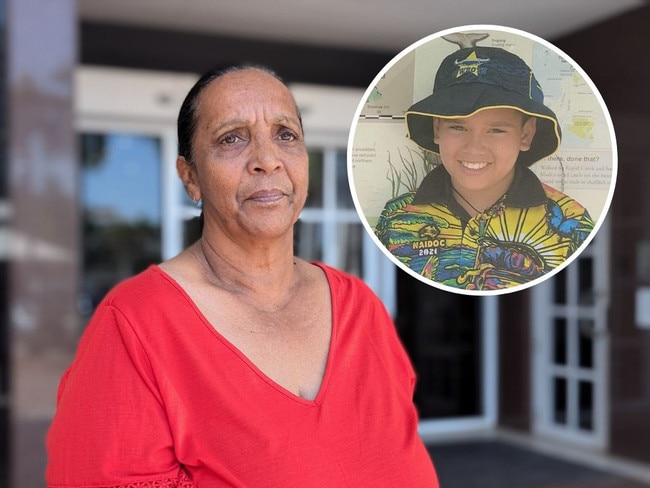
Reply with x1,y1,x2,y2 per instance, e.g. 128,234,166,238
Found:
375,46,593,290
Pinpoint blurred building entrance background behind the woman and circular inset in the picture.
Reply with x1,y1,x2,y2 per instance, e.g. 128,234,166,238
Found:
0,0,650,488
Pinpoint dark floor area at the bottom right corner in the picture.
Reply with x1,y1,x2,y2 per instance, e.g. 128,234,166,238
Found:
429,440,650,488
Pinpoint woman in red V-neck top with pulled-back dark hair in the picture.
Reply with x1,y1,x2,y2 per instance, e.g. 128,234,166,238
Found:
47,67,437,488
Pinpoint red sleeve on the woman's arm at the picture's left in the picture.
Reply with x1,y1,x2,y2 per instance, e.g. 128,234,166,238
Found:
46,304,195,488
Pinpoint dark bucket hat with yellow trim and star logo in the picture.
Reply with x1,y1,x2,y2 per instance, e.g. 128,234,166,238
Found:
405,46,562,166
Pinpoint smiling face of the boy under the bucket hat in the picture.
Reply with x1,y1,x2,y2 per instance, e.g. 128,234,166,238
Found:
433,108,536,200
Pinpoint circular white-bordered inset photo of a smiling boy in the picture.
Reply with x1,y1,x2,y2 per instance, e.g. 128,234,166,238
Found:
348,25,617,295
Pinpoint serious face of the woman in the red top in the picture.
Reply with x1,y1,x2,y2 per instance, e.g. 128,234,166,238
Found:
179,69,309,240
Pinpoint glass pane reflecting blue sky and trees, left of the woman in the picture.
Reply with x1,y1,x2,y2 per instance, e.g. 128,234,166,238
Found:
79,134,161,316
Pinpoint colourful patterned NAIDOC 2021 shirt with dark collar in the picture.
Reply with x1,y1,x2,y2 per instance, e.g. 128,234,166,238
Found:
375,166,594,290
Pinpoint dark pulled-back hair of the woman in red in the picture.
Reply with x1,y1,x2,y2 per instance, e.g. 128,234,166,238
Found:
177,64,302,164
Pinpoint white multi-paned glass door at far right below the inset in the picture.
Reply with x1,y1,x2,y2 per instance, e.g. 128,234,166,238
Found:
533,219,608,447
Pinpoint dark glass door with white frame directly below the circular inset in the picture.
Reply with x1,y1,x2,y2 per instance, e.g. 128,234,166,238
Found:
396,271,498,441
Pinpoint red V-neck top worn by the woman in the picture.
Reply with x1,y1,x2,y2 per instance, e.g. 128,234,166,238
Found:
47,265,438,488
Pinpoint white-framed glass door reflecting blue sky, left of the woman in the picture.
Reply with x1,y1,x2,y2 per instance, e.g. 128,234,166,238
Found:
77,116,183,333
